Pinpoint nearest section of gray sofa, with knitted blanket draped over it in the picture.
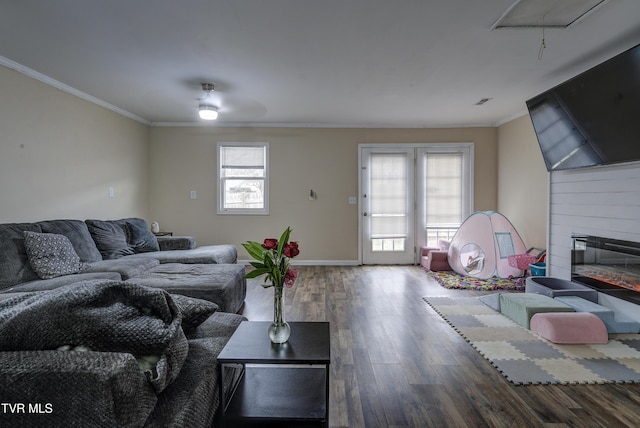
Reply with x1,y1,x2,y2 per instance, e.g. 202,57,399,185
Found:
0,280,245,428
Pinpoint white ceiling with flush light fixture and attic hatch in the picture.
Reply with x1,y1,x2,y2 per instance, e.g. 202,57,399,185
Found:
0,0,640,127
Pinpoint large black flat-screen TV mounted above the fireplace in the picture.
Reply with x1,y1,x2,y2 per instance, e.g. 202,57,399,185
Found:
527,45,640,171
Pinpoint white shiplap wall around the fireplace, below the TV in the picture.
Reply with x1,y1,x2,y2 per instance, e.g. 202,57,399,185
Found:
546,160,640,280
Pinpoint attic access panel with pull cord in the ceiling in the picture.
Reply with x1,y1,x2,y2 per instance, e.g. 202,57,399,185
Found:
491,0,607,30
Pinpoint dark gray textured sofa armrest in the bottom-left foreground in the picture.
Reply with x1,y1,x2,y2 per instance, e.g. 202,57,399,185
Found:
0,351,157,427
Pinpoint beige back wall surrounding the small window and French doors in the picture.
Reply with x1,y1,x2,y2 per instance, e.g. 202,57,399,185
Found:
150,126,498,261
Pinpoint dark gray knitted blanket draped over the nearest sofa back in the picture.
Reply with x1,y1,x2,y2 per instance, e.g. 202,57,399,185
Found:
0,280,188,393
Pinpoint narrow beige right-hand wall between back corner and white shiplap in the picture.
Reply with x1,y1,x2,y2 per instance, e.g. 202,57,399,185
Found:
498,115,549,248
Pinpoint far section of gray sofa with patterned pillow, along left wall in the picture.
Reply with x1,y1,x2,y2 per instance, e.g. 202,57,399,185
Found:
0,218,246,313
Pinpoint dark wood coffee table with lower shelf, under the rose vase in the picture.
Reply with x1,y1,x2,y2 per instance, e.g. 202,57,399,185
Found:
218,321,331,427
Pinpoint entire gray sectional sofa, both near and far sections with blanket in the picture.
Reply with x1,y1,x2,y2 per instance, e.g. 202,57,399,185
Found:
0,218,246,427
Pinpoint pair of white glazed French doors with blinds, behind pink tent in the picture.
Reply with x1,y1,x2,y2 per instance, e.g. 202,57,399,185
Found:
359,144,473,264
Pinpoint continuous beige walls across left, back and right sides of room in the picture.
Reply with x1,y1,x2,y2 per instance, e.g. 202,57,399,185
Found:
0,61,547,262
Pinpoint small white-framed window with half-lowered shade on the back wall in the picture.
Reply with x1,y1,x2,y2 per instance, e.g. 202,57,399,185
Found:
217,143,269,215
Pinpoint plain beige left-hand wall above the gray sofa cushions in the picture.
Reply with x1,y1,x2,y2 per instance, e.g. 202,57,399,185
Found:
0,66,149,223
